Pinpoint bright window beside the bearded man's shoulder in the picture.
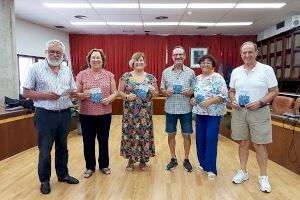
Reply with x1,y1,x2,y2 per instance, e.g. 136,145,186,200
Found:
18,54,45,93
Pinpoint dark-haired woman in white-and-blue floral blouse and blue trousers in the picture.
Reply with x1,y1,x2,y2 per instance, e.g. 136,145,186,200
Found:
191,55,228,179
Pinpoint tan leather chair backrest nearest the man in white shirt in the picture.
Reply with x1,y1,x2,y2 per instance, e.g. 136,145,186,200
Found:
272,96,295,115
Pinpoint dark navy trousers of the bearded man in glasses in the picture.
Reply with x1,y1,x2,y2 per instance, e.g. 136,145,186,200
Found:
35,108,71,182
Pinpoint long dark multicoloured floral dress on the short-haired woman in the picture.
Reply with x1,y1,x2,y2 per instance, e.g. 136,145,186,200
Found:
120,72,156,162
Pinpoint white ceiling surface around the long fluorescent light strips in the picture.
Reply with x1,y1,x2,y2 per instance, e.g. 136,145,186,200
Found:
15,0,300,35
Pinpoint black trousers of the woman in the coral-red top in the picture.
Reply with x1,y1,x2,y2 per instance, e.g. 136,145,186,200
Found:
80,114,111,170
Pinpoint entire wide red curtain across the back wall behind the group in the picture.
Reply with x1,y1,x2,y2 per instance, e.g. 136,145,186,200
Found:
70,34,256,83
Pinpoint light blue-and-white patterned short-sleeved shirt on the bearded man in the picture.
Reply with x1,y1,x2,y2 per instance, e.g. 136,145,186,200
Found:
22,60,76,110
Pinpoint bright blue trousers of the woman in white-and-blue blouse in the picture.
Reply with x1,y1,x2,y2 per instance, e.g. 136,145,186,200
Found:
196,115,221,174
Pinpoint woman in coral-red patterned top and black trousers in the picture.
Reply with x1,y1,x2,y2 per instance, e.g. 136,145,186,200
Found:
76,49,118,178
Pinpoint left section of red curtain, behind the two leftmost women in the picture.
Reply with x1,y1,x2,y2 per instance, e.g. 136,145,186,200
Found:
70,34,166,85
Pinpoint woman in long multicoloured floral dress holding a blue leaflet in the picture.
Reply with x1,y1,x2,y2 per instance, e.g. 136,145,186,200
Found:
119,52,158,170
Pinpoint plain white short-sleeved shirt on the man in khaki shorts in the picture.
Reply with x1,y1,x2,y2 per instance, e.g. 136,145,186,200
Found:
229,62,278,103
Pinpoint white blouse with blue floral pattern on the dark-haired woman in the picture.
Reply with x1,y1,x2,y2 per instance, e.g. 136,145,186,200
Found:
193,73,228,116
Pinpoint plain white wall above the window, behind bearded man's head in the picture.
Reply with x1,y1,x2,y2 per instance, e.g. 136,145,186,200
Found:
15,19,70,62
